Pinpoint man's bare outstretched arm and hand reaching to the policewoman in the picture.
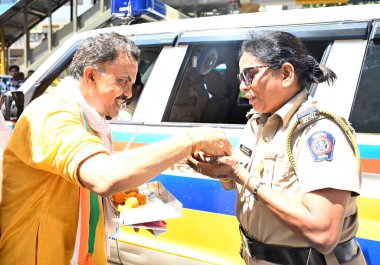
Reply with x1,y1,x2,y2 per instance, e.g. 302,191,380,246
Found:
78,128,232,196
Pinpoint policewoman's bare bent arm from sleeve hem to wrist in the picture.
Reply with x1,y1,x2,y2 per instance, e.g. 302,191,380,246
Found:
252,181,351,253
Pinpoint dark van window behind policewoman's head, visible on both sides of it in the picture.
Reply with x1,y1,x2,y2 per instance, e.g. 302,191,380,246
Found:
163,40,330,124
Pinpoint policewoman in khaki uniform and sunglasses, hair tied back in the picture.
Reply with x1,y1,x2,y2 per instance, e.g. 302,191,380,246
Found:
188,32,366,265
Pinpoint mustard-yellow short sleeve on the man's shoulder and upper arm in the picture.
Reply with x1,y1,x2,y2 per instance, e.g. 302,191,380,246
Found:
11,94,109,185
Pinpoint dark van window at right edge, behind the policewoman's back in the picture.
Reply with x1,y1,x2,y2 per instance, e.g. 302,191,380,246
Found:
349,40,380,133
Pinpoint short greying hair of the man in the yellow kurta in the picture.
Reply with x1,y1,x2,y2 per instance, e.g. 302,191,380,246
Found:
69,32,140,79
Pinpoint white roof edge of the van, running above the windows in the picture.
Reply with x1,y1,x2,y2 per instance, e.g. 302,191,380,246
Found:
21,4,380,106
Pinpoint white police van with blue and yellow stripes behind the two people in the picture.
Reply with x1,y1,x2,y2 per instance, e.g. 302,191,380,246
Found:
4,5,380,265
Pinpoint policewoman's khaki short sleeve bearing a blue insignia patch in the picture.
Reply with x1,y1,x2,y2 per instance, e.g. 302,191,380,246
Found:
295,119,361,194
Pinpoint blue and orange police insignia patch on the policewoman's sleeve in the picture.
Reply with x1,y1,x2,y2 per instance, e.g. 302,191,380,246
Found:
307,131,335,162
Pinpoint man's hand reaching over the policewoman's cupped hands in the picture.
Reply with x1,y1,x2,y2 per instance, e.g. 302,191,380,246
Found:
187,127,232,156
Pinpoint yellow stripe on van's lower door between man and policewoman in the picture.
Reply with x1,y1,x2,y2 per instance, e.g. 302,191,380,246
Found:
119,208,244,265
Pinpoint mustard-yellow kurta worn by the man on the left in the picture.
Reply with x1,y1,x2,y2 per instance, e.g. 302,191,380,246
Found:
0,87,108,265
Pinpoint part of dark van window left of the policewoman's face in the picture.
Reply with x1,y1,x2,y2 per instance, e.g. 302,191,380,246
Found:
168,44,239,123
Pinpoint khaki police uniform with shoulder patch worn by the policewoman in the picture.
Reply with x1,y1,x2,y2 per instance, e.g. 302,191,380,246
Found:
234,90,365,265
